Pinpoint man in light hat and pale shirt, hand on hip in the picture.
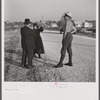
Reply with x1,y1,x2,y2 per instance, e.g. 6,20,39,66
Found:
54,12,76,68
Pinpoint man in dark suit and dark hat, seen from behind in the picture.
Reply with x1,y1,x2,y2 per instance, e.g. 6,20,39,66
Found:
21,19,35,68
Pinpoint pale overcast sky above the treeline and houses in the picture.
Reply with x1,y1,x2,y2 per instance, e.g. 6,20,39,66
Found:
4,0,96,21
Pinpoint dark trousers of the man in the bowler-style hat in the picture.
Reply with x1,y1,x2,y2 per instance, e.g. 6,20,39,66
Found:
21,49,33,66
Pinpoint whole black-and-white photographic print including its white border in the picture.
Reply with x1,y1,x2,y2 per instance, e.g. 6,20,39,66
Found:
2,0,99,100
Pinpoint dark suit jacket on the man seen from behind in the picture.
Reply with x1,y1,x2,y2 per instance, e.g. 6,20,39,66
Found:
21,26,35,50
